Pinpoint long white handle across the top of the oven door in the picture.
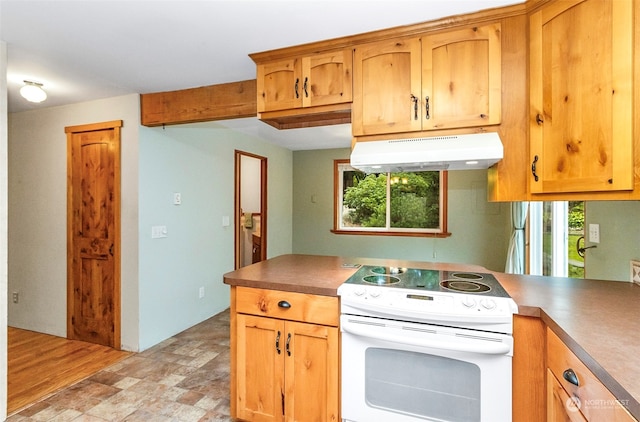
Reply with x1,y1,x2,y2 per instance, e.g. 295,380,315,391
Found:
342,323,511,355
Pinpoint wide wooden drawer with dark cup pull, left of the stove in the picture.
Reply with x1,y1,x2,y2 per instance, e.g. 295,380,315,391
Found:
236,286,340,327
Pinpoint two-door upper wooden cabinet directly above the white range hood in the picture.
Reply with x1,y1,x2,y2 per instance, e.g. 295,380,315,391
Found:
352,23,502,136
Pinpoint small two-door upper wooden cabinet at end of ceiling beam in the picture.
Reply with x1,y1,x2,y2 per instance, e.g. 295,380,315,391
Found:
256,49,353,113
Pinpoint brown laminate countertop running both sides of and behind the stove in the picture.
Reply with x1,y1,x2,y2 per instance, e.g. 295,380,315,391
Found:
224,255,640,419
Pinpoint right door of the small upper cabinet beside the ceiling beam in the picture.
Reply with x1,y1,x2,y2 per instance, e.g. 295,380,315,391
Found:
302,49,353,107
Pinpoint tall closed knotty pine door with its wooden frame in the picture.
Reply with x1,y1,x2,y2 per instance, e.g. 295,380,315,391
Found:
65,121,122,349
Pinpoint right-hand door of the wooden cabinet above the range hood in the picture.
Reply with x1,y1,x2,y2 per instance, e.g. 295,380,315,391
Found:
420,23,502,130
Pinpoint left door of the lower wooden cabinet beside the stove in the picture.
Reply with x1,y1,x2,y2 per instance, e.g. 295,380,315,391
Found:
234,314,286,422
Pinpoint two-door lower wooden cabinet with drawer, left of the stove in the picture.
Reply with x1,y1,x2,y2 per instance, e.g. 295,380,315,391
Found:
231,287,340,422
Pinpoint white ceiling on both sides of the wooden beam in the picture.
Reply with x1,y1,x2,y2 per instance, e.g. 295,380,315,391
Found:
0,0,522,150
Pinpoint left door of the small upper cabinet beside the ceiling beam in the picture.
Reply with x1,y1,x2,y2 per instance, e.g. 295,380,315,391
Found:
256,58,303,113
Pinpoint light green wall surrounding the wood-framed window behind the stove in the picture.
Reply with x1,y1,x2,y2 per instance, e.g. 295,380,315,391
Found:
293,149,511,271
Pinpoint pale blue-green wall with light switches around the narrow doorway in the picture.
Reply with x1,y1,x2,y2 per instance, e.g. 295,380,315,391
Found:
139,123,292,350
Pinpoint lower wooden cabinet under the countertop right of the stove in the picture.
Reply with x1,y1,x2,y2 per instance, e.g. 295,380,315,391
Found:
547,328,636,422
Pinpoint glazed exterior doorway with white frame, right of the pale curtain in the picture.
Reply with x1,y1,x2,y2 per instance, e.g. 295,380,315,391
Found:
529,201,585,278
